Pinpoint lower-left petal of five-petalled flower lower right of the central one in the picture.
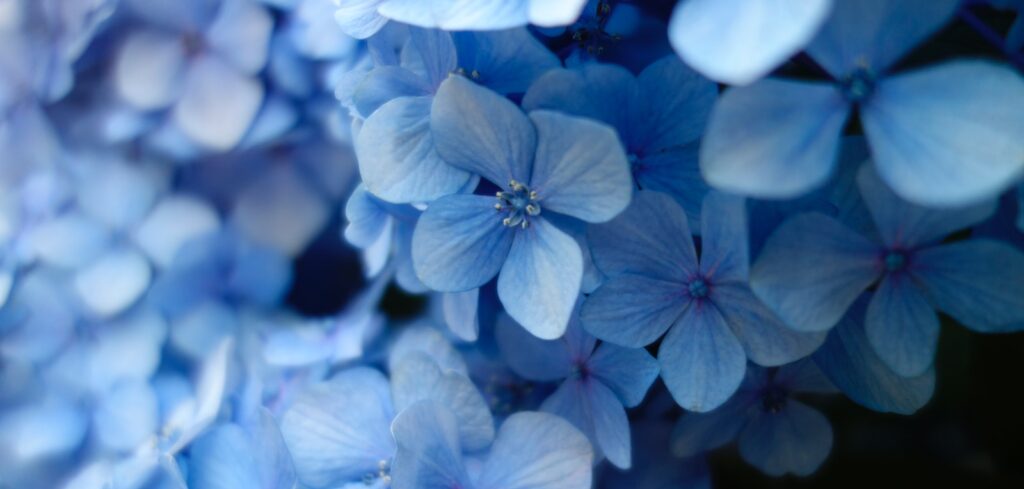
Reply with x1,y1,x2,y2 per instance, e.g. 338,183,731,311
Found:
580,273,689,348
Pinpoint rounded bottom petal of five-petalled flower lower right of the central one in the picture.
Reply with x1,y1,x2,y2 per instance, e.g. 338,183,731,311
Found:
657,303,746,412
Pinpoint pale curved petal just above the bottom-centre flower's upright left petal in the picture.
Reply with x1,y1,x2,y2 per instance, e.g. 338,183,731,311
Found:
391,353,495,451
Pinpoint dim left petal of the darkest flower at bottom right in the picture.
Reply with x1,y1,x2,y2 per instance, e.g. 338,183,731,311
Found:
672,388,753,457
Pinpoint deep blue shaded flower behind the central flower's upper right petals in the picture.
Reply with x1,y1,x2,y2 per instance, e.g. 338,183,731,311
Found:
522,56,718,223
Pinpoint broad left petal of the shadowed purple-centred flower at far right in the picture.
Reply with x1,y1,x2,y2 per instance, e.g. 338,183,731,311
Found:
751,213,882,331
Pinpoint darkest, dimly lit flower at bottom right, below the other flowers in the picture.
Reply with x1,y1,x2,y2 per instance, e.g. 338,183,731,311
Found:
672,359,836,476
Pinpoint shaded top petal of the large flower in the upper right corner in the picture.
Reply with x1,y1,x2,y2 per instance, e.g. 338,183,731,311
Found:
807,0,959,78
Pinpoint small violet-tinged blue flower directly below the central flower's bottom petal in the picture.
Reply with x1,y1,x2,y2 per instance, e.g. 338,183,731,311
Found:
495,304,657,469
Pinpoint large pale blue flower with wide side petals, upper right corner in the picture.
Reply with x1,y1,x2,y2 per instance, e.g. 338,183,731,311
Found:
700,0,1024,207
